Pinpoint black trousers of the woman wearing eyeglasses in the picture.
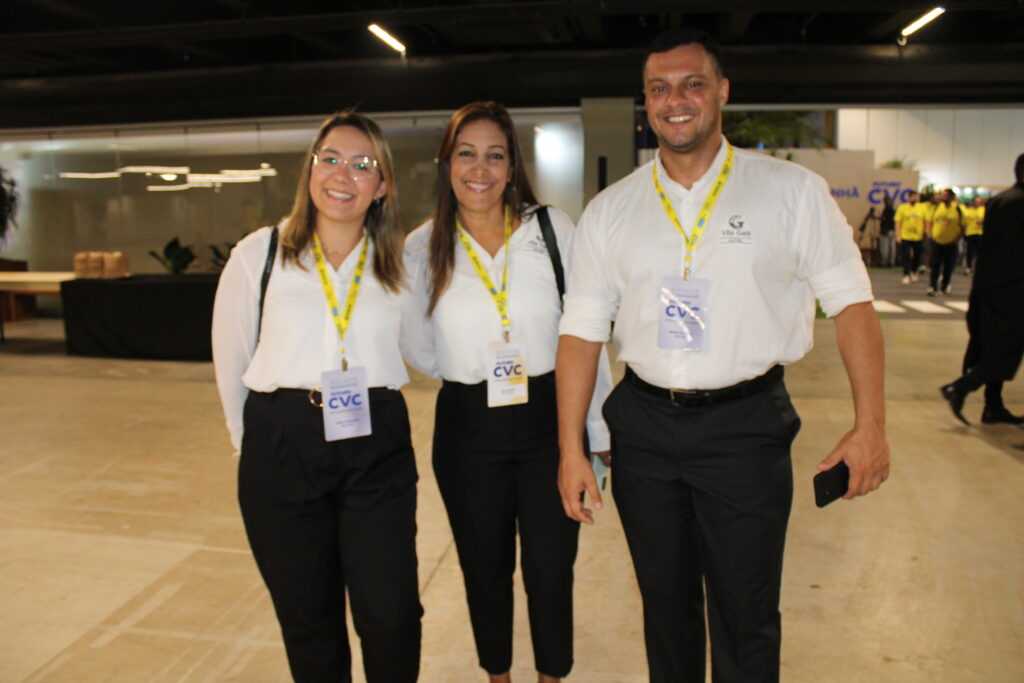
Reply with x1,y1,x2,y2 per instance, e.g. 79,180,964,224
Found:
239,389,423,683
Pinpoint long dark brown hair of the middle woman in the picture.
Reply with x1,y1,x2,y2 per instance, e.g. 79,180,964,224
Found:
427,101,537,315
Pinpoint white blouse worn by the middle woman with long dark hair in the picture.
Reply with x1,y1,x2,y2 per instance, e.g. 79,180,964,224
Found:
406,207,611,451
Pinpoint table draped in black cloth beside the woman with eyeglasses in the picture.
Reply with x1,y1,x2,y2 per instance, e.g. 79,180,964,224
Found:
60,273,220,360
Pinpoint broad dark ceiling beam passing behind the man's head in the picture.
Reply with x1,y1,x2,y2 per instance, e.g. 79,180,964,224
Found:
0,44,1024,128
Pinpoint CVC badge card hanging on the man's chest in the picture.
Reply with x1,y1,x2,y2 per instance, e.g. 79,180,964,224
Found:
657,278,711,353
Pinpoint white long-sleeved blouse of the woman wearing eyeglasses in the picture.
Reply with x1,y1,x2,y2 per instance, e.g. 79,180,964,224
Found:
213,222,411,450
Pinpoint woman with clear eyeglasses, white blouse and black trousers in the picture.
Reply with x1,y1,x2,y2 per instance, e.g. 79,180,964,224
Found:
213,112,423,683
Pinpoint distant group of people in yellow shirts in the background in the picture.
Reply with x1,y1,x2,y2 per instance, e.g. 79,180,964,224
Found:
858,188,985,296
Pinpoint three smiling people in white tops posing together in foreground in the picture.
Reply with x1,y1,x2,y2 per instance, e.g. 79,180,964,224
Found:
213,30,889,683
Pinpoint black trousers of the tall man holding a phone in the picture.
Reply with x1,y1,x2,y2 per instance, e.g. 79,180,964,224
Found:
604,379,800,683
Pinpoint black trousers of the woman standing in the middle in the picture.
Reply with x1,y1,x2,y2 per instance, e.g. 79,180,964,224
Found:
433,373,580,678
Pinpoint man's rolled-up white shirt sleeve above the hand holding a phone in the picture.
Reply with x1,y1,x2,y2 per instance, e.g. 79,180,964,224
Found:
795,175,874,317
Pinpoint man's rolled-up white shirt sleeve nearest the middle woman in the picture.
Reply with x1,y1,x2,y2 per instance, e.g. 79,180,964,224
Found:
558,202,618,342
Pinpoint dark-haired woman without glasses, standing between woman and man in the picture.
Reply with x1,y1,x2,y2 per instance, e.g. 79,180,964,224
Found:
406,102,610,683
